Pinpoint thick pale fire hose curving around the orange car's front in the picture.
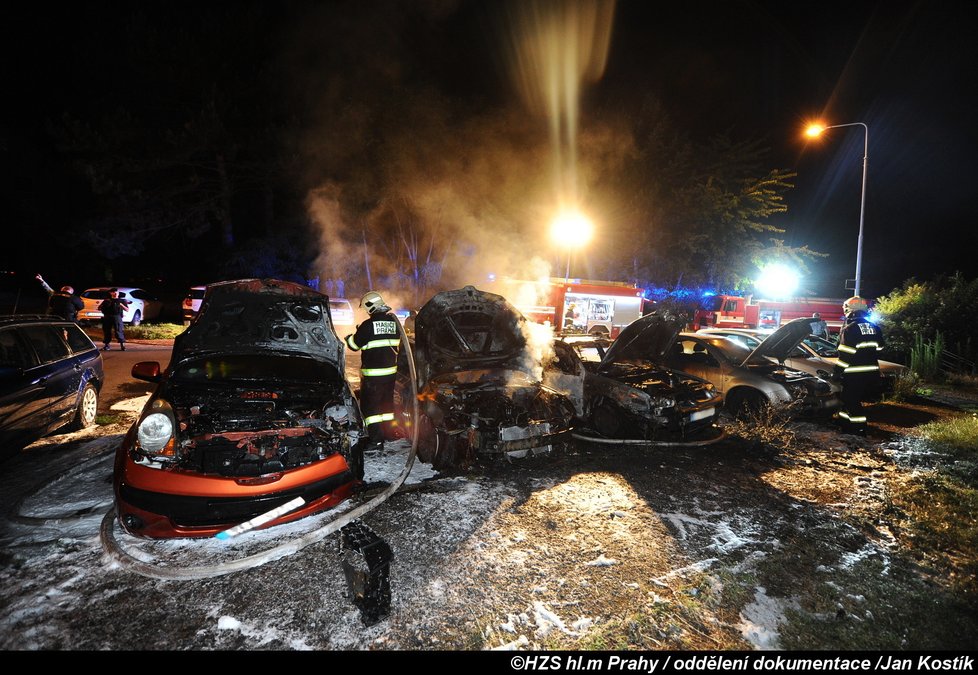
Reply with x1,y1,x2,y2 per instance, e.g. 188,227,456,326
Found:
99,321,419,579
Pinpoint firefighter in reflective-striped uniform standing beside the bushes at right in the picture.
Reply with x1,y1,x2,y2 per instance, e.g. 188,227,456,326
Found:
833,295,883,434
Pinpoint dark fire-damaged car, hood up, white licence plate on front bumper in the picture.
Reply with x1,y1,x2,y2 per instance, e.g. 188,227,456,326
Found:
544,313,723,442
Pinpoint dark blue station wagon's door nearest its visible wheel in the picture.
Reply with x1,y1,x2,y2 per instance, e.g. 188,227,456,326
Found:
18,324,81,429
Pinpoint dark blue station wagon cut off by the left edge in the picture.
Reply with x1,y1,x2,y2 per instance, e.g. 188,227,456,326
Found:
0,315,105,453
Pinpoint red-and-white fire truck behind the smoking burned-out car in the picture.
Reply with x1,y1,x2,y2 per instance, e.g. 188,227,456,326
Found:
488,277,647,337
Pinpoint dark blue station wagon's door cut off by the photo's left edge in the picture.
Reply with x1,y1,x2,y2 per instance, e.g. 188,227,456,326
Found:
0,327,45,449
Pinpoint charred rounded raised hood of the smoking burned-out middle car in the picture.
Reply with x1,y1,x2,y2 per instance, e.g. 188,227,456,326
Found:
414,286,531,386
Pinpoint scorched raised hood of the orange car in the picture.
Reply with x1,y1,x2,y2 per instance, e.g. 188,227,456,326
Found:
171,279,344,373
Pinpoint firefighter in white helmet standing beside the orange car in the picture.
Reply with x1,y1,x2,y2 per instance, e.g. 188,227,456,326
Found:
345,291,401,449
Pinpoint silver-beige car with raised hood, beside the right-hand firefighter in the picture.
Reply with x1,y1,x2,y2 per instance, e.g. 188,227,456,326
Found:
666,318,842,415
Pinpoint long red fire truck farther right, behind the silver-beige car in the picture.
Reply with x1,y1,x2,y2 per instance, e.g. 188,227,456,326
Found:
692,295,845,333
